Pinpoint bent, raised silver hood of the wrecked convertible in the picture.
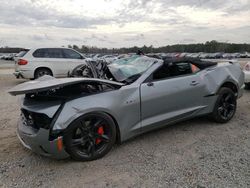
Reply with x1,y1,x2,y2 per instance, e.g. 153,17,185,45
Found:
8,75,124,95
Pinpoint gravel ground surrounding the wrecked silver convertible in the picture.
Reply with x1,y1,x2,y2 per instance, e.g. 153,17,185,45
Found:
0,75,250,188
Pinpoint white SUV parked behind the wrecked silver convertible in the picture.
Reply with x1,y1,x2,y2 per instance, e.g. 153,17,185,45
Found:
14,48,88,79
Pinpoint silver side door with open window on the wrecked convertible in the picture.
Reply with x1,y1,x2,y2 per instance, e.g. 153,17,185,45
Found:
140,62,205,130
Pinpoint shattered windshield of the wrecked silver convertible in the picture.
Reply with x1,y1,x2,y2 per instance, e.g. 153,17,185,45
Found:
108,55,157,82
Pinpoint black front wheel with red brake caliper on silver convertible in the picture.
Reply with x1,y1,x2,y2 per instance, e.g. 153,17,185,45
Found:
63,112,116,161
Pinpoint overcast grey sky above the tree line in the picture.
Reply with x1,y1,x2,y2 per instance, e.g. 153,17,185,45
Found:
0,0,250,48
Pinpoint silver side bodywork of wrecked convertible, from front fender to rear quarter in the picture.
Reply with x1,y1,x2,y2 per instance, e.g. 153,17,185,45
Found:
53,61,242,141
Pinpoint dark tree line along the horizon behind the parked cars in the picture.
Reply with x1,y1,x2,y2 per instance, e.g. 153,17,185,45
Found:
0,40,250,54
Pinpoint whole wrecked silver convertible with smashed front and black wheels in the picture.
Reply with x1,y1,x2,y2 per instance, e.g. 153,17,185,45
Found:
9,56,244,161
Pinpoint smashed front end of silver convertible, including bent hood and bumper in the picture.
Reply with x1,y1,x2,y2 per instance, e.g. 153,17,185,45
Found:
9,76,122,159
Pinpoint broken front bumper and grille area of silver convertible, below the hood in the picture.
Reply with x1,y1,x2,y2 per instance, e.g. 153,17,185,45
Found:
17,98,68,159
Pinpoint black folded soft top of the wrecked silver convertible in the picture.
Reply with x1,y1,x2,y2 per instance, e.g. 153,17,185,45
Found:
164,58,218,69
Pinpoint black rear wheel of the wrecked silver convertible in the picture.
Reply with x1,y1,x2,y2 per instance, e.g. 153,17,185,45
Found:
212,87,237,123
